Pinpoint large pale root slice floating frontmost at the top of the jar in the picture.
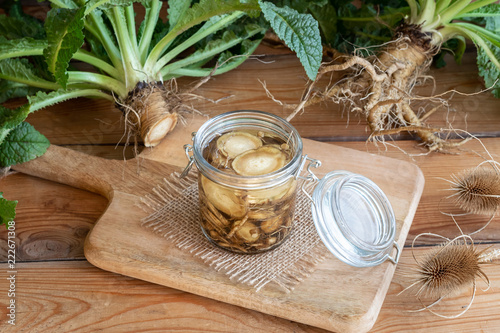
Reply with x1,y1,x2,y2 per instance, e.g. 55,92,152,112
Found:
232,146,286,176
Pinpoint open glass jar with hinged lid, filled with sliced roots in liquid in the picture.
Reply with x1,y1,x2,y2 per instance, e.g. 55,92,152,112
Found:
185,111,400,267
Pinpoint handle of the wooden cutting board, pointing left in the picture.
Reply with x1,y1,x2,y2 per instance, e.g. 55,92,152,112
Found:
12,145,117,198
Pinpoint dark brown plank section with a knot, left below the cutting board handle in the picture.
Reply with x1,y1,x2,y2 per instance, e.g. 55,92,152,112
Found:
0,173,108,262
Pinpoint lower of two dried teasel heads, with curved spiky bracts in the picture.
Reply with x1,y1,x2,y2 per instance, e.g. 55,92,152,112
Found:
399,233,500,319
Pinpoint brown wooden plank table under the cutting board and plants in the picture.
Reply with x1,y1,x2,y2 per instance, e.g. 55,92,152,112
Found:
0,21,500,332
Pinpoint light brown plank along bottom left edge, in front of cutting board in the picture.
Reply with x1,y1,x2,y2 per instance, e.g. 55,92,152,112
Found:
0,261,323,333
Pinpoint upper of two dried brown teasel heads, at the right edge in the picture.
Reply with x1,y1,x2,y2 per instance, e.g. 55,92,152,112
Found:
451,167,500,215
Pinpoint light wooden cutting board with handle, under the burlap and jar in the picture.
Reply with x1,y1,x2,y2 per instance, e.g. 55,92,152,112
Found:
15,118,424,332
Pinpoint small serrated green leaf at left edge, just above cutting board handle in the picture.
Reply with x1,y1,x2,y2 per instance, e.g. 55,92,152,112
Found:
0,122,50,166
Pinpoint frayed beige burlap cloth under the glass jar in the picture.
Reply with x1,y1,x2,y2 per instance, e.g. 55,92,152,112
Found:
142,171,329,292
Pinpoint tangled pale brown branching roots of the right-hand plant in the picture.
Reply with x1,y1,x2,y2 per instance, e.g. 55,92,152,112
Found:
285,24,474,151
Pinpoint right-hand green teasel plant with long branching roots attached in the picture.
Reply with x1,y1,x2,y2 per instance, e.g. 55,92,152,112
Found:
280,0,500,151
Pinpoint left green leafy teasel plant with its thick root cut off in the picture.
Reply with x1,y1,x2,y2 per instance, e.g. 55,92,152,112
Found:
0,0,322,223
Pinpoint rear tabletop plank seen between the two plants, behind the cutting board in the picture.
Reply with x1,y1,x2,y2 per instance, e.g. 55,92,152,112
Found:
7,45,500,145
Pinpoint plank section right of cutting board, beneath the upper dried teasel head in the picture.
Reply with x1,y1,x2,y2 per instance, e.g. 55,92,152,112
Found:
330,138,500,246
